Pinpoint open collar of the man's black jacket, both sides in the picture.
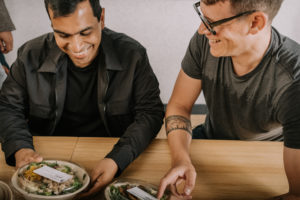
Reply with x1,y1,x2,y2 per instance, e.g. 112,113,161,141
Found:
38,28,124,73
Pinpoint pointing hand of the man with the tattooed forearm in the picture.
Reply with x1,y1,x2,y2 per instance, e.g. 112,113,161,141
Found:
157,162,197,199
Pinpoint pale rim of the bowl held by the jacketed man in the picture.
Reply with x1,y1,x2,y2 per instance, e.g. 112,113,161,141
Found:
11,160,90,200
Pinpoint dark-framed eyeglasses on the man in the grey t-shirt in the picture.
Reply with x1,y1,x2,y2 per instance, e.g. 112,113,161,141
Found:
194,1,256,35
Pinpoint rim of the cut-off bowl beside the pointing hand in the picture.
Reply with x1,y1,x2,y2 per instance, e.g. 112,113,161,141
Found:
104,178,170,200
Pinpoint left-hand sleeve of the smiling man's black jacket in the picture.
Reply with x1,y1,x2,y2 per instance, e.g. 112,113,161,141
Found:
0,56,33,165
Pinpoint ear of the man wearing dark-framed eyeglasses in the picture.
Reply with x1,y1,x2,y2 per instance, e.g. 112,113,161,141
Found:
249,11,269,35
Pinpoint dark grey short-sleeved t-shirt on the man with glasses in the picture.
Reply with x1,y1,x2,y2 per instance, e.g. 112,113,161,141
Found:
182,28,300,148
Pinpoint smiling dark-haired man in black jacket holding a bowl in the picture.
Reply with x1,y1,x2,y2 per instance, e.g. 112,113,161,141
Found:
0,0,164,195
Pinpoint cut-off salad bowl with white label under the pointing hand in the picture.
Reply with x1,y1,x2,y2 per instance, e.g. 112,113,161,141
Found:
104,179,170,200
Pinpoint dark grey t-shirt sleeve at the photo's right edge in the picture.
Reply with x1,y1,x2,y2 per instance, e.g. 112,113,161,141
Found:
277,81,300,149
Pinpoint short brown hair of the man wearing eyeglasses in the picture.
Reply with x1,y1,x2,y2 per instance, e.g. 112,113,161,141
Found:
201,0,283,22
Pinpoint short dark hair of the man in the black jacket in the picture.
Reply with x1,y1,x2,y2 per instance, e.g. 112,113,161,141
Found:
44,0,102,21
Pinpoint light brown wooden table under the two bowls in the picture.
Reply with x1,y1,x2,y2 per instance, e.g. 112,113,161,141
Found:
0,137,288,200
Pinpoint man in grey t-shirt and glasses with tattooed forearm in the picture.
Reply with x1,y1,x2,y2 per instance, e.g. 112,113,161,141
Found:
158,0,300,200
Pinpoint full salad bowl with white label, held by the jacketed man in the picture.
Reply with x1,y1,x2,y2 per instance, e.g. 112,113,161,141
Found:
11,160,90,200
